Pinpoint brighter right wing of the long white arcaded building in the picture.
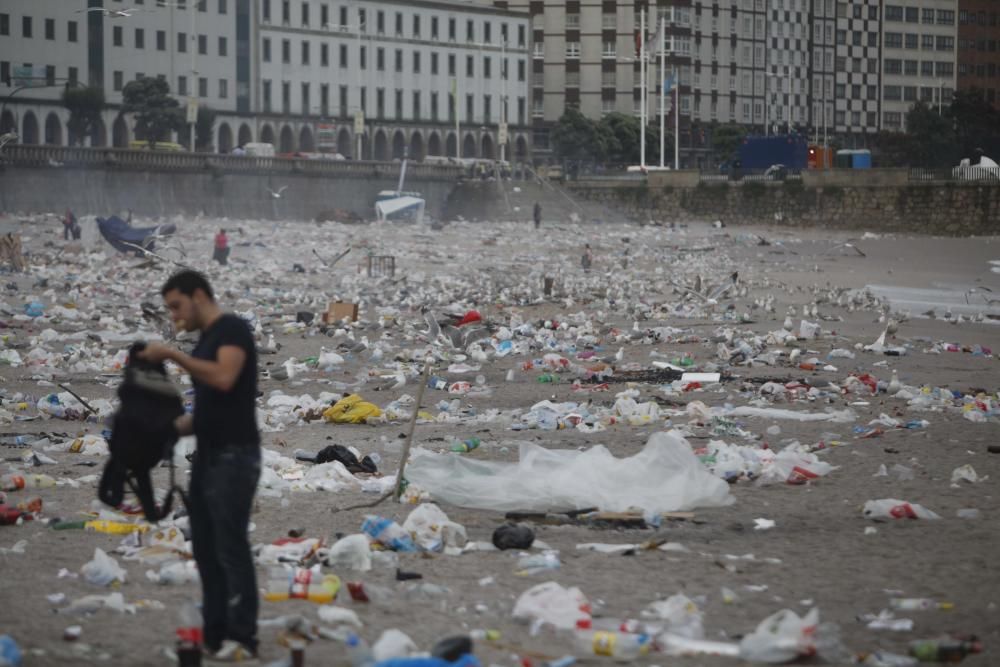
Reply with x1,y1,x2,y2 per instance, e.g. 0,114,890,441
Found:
255,0,529,159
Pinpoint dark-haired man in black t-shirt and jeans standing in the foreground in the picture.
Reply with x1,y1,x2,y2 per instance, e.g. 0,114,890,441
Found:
141,270,260,664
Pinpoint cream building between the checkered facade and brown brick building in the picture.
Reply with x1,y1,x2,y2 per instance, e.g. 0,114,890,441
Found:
879,0,958,130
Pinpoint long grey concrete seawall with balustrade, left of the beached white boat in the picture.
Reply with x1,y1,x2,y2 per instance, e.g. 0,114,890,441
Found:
0,146,460,220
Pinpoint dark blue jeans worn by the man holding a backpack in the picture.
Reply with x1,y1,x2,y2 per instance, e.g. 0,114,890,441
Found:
188,445,260,651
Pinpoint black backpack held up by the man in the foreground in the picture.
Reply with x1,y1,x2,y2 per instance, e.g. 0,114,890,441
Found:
97,343,184,523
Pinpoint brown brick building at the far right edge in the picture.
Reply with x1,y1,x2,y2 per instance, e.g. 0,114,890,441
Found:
957,0,1000,109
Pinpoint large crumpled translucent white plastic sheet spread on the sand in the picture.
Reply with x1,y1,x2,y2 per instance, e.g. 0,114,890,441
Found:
406,431,734,514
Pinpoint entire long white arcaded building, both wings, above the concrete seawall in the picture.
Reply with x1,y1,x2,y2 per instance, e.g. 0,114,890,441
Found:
0,0,530,159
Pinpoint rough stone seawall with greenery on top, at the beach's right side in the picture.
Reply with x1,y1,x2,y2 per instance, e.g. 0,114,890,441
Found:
568,170,1000,236
